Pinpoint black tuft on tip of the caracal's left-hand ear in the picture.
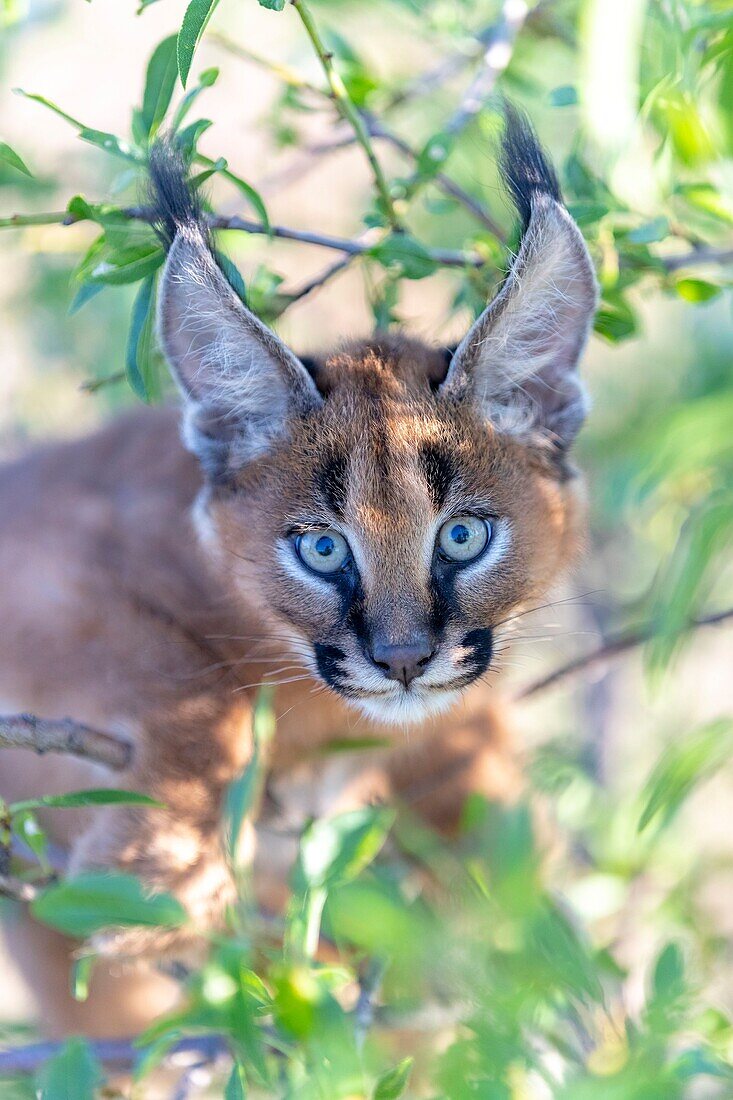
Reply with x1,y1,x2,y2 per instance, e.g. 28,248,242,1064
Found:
150,138,208,249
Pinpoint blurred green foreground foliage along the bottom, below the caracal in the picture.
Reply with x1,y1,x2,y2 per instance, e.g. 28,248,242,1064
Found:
1,702,733,1100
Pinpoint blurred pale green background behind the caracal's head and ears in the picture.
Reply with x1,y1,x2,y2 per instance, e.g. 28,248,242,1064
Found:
0,0,733,1097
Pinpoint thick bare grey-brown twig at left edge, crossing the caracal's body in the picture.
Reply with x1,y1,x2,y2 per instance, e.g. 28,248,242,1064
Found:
0,714,132,771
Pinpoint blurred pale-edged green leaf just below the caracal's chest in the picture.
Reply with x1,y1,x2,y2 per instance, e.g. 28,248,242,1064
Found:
296,806,394,889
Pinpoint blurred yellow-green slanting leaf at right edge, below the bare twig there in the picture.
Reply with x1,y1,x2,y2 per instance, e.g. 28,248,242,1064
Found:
637,718,733,833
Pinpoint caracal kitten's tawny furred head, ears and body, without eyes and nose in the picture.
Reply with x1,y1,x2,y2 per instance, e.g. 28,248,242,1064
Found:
0,114,595,1035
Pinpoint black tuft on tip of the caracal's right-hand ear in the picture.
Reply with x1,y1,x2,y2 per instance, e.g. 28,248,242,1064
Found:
500,103,562,230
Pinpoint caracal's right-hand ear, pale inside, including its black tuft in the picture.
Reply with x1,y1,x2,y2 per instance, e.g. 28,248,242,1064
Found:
441,108,597,450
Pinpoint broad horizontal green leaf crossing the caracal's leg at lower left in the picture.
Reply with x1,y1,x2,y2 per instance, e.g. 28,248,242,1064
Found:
31,871,186,939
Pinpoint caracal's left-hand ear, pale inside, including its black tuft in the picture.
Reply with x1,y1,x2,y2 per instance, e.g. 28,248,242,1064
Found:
150,142,322,479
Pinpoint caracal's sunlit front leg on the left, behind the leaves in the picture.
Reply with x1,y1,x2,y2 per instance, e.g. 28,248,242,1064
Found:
69,707,252,958
